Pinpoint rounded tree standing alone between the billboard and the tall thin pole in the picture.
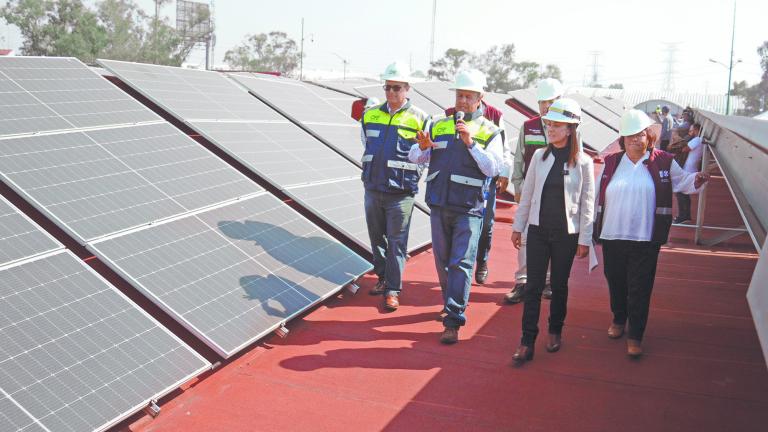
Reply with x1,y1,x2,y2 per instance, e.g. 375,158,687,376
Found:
224,31,301,76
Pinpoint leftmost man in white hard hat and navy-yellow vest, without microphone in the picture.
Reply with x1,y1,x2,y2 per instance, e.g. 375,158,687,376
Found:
360,62,429,311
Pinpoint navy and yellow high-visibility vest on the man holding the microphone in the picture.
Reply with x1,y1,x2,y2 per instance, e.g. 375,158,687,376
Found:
426,111,499,216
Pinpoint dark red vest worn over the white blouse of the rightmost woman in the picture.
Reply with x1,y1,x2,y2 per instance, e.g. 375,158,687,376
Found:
593,149,674,244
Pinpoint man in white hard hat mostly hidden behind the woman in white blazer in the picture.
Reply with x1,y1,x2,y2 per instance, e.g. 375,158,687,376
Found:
504,78,560,304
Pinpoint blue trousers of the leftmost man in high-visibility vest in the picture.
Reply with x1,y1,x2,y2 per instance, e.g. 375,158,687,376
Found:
365,190,414,295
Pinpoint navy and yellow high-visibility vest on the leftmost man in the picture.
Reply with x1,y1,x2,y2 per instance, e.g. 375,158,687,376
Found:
361,101,429,195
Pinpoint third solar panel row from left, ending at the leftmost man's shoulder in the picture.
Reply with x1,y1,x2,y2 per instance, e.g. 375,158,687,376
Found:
232,75,363,165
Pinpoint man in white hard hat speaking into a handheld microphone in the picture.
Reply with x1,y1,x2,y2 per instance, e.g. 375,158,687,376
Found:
408,69,503,344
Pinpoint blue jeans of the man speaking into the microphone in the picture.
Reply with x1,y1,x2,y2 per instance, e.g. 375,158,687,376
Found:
430,207,483,327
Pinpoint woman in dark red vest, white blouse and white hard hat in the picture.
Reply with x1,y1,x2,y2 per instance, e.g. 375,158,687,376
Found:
594,110,709,358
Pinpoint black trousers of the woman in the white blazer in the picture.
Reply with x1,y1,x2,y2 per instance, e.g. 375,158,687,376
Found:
520,225,579,346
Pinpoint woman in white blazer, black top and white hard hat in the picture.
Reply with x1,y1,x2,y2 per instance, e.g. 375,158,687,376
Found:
512,99,595,365
